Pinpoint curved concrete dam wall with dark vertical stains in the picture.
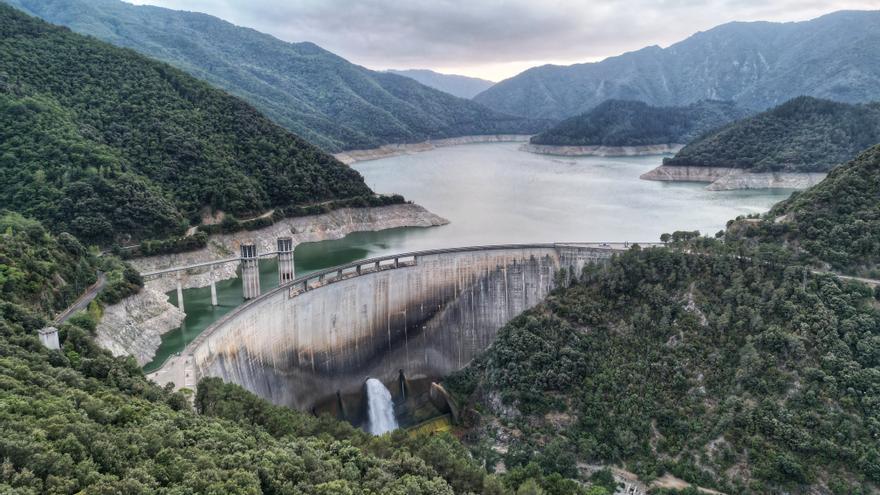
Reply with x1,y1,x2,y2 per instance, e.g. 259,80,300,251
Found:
150,243,645,410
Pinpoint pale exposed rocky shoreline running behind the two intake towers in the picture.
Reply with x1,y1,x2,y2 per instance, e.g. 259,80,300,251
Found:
96,203,449,366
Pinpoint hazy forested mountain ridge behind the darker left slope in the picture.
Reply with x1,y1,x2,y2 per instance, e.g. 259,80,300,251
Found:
6,0,542,151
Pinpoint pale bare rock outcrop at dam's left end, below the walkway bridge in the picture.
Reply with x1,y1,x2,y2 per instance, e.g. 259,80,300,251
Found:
95,289,185,366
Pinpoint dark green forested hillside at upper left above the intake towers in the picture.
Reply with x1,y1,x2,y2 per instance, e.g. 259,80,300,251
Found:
0,5,371,244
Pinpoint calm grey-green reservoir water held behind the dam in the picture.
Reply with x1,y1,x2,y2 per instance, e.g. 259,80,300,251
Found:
144,143,791,371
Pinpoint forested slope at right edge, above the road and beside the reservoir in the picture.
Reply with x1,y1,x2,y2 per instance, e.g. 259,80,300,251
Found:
727,145,880,279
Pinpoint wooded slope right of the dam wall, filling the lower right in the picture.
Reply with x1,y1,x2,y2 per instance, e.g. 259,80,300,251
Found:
447,248,880,494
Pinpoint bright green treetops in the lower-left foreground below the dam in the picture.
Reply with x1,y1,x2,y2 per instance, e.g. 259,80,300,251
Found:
0,214,510,495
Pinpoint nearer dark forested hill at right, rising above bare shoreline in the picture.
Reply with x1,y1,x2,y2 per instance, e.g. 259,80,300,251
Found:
663,96,880,172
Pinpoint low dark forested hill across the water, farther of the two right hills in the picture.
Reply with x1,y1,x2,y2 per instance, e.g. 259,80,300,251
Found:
531,100,749,146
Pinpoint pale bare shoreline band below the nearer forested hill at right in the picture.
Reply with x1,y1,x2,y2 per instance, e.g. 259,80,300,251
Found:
640,165,827,191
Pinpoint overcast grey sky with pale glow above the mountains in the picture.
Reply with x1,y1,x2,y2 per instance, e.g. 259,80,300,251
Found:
129,0,880,81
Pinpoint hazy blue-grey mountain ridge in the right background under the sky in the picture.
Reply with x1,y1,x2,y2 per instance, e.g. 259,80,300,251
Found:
474,11,880,119
